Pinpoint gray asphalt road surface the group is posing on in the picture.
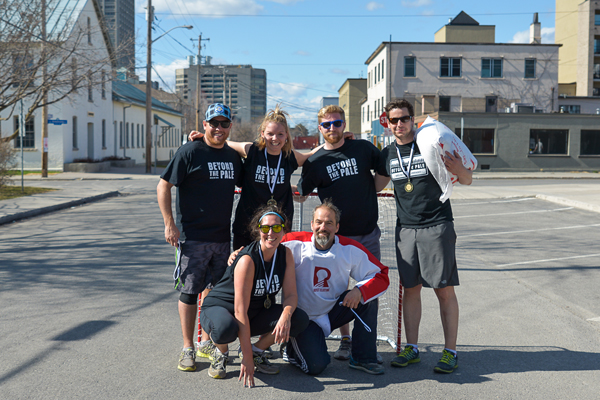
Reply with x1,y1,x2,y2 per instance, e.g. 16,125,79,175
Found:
0,180,600,399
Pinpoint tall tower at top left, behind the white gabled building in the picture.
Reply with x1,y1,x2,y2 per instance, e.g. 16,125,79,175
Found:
97,0,135,74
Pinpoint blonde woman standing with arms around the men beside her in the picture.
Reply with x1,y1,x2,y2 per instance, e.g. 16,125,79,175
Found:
189,105,322,249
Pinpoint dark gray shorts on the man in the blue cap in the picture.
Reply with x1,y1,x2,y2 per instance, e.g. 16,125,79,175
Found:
177,240,230,294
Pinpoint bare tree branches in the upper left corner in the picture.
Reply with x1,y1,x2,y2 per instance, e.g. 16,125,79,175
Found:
0,0,122,141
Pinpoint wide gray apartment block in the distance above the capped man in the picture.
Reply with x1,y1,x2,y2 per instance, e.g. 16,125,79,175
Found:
175,63,267,122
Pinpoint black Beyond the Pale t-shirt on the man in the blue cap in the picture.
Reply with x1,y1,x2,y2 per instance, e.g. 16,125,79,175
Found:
161,140,242,243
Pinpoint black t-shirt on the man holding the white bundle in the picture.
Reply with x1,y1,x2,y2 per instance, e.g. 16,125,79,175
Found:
377,142,452,228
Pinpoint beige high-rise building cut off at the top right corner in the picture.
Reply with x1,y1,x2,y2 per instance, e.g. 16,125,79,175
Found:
554,0,600,97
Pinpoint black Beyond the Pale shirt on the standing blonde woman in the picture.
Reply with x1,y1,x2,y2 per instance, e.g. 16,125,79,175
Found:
233,144,298,240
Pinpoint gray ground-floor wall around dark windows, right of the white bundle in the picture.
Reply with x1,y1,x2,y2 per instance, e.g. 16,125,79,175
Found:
439,112,600,171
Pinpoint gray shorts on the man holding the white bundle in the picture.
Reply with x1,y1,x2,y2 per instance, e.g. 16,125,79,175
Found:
396,221,459,289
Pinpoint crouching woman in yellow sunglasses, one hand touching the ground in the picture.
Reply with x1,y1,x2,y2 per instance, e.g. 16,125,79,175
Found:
200,206,308,387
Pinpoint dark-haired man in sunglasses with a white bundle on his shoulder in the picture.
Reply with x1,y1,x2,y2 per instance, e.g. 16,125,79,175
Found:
375,99,472,373
